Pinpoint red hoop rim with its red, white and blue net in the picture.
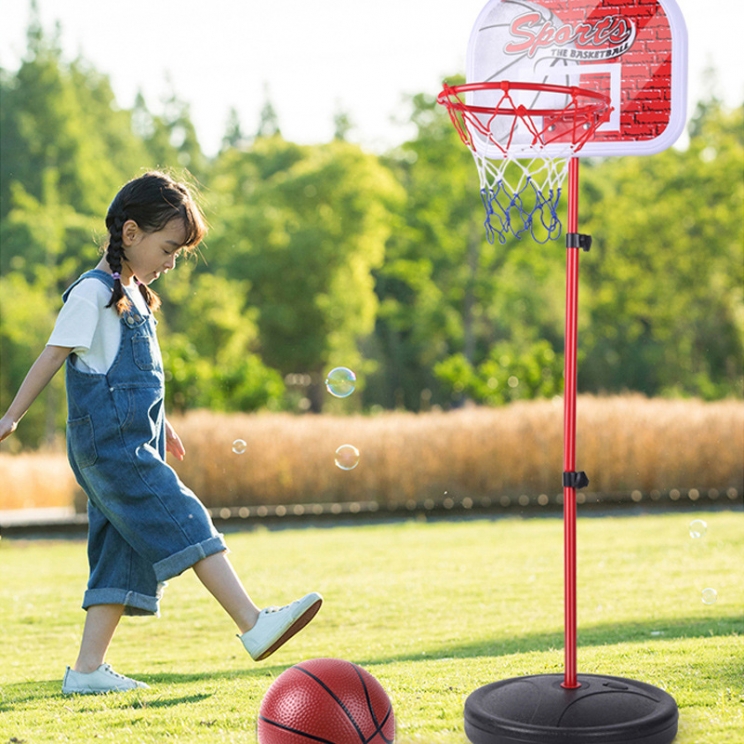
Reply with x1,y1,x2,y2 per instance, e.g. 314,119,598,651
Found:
437,81,611,243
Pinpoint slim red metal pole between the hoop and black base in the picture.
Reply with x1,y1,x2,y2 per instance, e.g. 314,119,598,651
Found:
562,158,581,689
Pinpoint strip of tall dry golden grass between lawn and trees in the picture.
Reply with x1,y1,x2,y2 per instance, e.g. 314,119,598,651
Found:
0,395,744,509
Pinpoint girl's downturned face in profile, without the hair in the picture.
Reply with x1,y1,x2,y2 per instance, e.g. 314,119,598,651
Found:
122,217,186,284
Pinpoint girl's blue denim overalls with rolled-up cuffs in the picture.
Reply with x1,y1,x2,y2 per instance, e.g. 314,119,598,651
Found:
63,269,226,615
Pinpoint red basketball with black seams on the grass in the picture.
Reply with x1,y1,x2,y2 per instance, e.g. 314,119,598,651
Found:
258,659,395,744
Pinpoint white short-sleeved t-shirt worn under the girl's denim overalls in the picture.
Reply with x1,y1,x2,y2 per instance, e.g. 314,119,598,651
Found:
47,277,149,374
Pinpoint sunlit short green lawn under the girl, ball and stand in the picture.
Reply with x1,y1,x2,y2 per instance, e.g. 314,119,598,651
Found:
0,511,744,744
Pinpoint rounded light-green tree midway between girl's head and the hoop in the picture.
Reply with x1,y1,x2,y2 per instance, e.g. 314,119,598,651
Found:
206,136,401,411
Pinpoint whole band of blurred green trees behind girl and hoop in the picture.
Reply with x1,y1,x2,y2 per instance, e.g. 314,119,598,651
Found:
0,18,744,447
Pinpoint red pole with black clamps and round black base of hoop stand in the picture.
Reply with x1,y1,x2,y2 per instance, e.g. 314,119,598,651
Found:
465,157,679,744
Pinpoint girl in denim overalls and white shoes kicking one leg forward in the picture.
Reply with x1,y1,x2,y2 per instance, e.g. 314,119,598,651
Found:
0,172,323,694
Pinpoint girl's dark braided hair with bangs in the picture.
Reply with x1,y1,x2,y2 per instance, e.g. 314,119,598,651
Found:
105,171,207,315
